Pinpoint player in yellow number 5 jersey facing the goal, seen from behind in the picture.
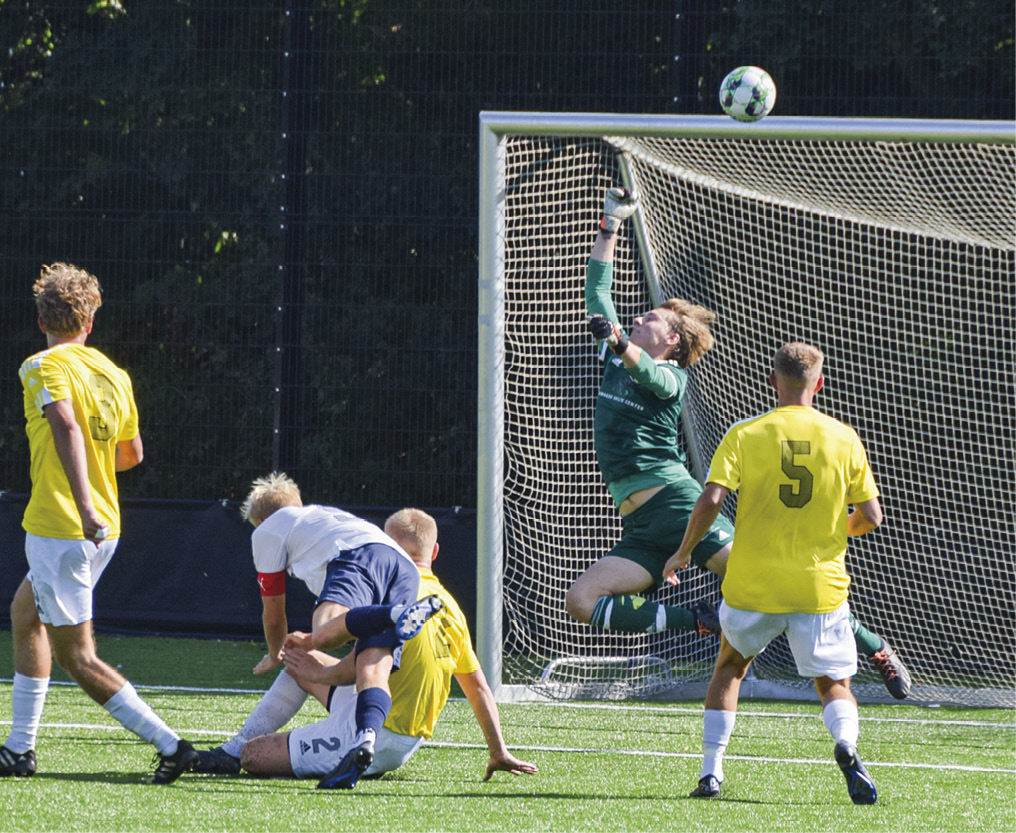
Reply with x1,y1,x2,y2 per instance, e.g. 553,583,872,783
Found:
663,342,882,805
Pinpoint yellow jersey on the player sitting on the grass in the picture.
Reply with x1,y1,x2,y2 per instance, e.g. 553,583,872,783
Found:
384,568,480,739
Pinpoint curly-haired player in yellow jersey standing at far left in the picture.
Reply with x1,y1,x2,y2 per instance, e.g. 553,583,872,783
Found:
0,263,197,783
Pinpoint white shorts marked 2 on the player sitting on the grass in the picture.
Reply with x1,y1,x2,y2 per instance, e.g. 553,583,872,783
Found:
289,686,424,778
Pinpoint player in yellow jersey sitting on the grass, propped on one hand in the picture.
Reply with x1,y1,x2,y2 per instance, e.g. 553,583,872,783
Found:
241,509,536,788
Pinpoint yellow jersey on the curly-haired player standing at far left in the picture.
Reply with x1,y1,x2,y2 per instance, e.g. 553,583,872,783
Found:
20,342,138,539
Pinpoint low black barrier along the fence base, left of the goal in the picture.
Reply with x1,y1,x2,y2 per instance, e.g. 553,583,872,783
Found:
0,495,477,639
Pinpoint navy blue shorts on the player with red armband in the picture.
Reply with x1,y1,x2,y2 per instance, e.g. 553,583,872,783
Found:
317,543,420,666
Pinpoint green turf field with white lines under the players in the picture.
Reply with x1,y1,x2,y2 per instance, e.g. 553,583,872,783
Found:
0,635,1016,833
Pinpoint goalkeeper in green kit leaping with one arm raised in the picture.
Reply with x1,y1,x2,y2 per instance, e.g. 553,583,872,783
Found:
565,188,910,699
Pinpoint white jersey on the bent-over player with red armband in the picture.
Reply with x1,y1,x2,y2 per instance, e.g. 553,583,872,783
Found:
251,505,412,596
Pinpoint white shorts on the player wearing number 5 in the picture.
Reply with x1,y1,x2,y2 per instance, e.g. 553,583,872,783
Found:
719,601,858,680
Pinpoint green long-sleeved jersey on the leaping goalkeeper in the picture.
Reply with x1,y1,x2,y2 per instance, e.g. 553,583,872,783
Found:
585,260,692,505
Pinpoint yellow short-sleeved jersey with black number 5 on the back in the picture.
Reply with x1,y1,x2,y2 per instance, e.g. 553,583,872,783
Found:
708,405,879,614
